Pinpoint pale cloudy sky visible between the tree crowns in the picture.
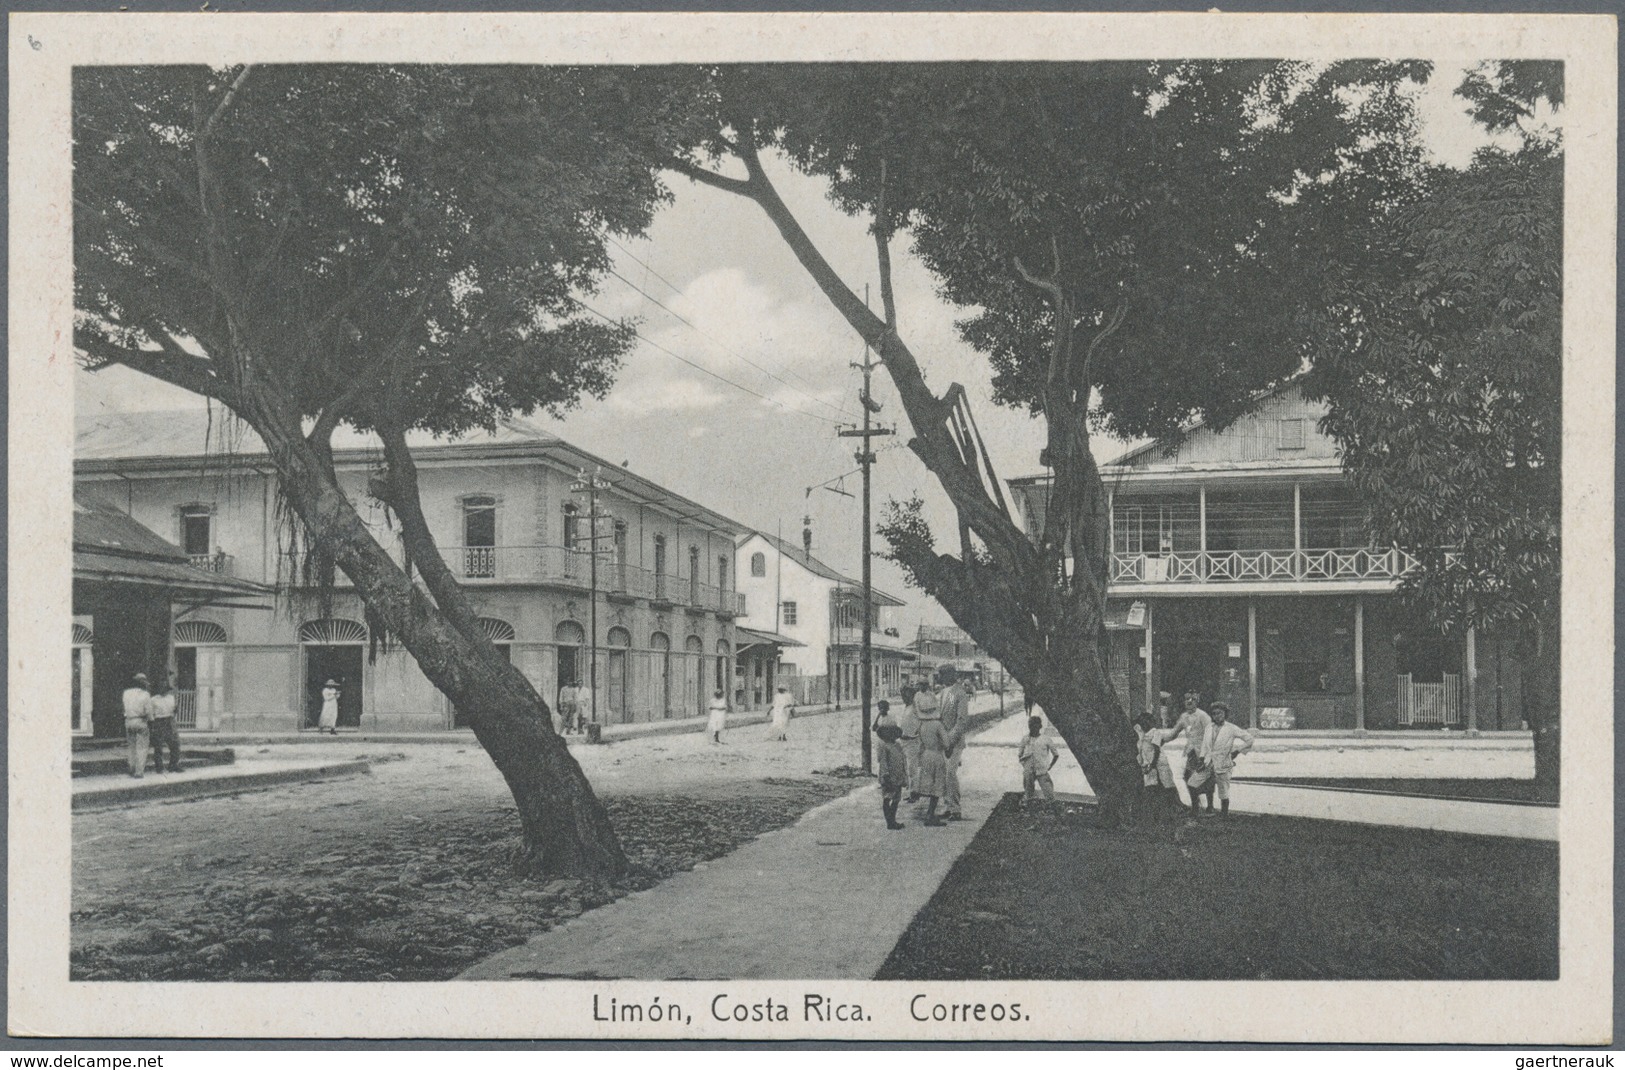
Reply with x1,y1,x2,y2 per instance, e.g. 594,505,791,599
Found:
75,62,1484,636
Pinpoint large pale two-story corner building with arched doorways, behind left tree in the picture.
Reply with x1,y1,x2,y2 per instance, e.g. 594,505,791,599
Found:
75,411,744,730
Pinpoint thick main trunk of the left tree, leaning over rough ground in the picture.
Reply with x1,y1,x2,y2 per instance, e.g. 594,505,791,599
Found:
250,398,626,880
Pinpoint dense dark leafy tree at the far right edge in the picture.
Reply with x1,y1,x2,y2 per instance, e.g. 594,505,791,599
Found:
1307,62,1563,797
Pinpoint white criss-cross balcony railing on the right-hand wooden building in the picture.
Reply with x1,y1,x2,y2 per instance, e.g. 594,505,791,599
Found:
1112,546,1417,584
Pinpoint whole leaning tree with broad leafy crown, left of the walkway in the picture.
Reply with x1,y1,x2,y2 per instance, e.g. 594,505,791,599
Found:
73,65,695,878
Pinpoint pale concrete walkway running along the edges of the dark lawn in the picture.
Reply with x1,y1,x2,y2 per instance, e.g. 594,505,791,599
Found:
462,696,1557,981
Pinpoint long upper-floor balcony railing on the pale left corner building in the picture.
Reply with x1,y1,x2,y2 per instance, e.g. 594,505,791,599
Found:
281,546,744,616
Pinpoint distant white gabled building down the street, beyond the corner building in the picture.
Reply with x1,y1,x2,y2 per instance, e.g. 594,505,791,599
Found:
738,528,915,704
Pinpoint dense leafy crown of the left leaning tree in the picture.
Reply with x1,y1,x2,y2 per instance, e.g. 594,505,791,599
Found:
73,65,692,433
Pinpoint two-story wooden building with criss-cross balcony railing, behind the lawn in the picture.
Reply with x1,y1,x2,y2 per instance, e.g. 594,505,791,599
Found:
1012,384,1524,730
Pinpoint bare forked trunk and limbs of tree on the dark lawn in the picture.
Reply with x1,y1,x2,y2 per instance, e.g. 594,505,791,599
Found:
670,129,1141,823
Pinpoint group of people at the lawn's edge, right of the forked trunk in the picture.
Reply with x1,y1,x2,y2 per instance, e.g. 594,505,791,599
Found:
1134,691,1253,816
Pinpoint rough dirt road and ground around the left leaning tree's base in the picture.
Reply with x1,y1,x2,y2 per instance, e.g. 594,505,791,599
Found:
72,711,903,981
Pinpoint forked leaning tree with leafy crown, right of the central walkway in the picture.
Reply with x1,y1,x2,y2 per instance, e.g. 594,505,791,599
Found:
653,62,1427,820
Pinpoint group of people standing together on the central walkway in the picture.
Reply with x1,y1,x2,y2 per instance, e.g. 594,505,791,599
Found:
874,668,970,829
